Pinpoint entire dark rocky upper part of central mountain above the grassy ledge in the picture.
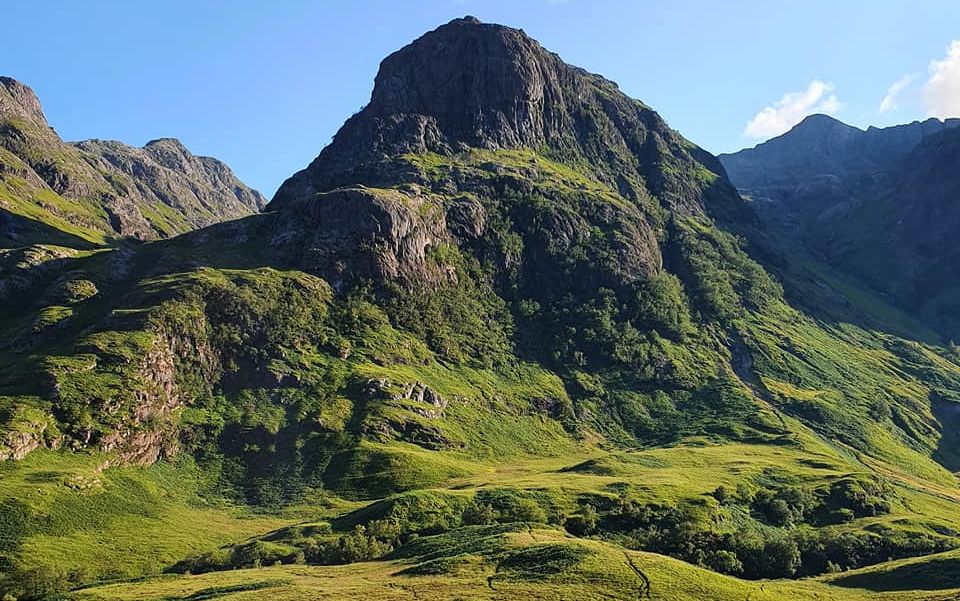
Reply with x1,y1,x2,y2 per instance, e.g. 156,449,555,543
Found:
271,17,739,221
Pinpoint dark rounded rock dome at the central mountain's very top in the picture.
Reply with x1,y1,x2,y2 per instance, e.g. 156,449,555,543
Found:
368,17,568,148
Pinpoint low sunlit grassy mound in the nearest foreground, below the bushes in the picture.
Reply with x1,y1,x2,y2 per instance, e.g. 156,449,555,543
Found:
72,527,958,601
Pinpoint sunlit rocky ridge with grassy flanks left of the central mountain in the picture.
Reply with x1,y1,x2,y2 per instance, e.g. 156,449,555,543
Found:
0,77,266,247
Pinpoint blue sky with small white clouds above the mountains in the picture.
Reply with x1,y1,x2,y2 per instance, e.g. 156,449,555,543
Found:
0,0,960,196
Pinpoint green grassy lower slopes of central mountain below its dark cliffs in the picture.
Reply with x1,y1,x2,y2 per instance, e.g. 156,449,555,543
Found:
0,144,960,599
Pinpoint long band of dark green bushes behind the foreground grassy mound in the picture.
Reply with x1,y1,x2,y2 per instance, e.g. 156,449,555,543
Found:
167,477,951,579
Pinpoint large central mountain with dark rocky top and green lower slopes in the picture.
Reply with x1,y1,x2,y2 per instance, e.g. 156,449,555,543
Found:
0,17,960,599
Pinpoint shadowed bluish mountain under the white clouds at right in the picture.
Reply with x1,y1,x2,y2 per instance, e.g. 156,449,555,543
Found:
720,115,960,339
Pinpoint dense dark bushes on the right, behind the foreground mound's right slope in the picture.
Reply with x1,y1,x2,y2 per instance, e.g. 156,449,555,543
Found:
565,477,952,579
